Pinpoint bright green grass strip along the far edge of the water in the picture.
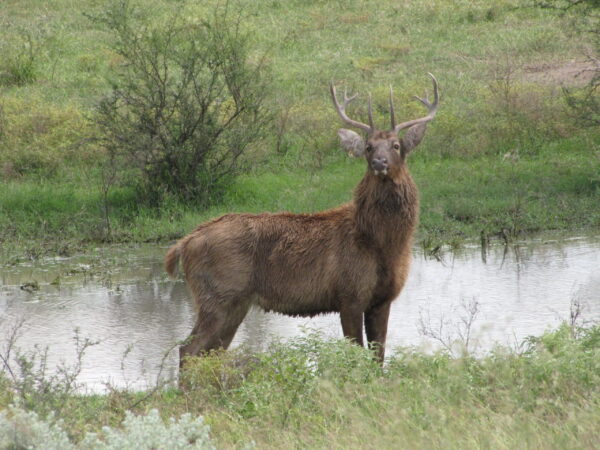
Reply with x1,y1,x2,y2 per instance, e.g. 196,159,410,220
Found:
0,128,600,260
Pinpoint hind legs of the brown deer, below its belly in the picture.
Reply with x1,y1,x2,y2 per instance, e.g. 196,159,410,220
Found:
179,298,251,367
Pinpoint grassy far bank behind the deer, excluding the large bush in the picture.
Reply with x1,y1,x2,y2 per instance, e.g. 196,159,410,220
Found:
0,0,600,257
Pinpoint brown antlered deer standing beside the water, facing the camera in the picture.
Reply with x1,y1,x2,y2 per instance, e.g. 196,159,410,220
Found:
165,74,439,367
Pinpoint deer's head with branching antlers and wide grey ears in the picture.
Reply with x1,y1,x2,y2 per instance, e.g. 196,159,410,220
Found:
329,74,439,178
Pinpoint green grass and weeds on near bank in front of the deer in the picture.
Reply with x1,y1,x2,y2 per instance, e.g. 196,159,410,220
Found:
0,324,600,448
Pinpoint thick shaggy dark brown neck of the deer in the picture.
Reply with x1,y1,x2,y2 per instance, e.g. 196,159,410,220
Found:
354,168,419,252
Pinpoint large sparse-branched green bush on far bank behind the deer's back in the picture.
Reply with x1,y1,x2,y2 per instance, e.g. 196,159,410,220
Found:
93,0,270,205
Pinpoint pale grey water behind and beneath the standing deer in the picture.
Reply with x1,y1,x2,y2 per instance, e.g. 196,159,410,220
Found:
0,237,600,390
